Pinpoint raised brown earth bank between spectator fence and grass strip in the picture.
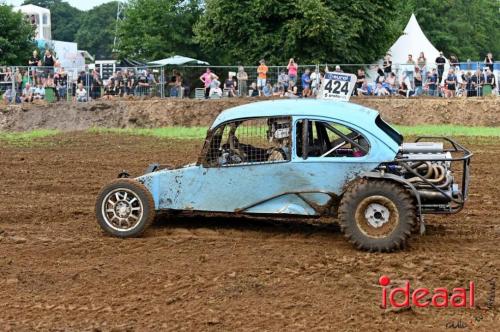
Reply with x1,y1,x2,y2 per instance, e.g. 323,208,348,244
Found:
0,97,500,131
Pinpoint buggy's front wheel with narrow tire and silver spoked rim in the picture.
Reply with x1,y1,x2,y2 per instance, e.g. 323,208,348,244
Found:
95,179,155,238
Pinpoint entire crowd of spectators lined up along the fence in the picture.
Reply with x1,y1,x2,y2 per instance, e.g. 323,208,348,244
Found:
0,50,498,103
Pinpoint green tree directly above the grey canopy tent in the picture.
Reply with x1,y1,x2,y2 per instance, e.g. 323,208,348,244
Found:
118,0,202,60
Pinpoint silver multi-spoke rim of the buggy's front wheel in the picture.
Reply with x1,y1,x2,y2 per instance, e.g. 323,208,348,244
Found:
102,188,144,232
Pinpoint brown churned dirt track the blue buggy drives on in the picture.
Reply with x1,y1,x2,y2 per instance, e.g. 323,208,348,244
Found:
0,133,500,331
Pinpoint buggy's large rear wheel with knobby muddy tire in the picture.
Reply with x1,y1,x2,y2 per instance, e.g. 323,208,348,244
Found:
339,179,417,252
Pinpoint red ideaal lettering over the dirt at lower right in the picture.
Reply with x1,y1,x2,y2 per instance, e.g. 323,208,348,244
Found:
378,276,475,309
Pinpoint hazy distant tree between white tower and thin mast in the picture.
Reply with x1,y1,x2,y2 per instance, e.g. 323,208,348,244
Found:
75,1,118,59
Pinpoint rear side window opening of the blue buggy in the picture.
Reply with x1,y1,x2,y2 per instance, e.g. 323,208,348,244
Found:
297,120,370,158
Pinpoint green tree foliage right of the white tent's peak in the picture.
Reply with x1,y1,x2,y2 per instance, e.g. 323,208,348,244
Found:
398,0,500,61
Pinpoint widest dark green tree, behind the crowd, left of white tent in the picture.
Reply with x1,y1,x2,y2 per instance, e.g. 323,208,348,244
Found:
194,0,397,64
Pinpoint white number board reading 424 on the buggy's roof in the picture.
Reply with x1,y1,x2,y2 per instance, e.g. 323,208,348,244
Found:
319,72,356,101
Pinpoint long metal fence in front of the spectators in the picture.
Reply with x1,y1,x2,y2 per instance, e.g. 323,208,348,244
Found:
0,61,500,103
